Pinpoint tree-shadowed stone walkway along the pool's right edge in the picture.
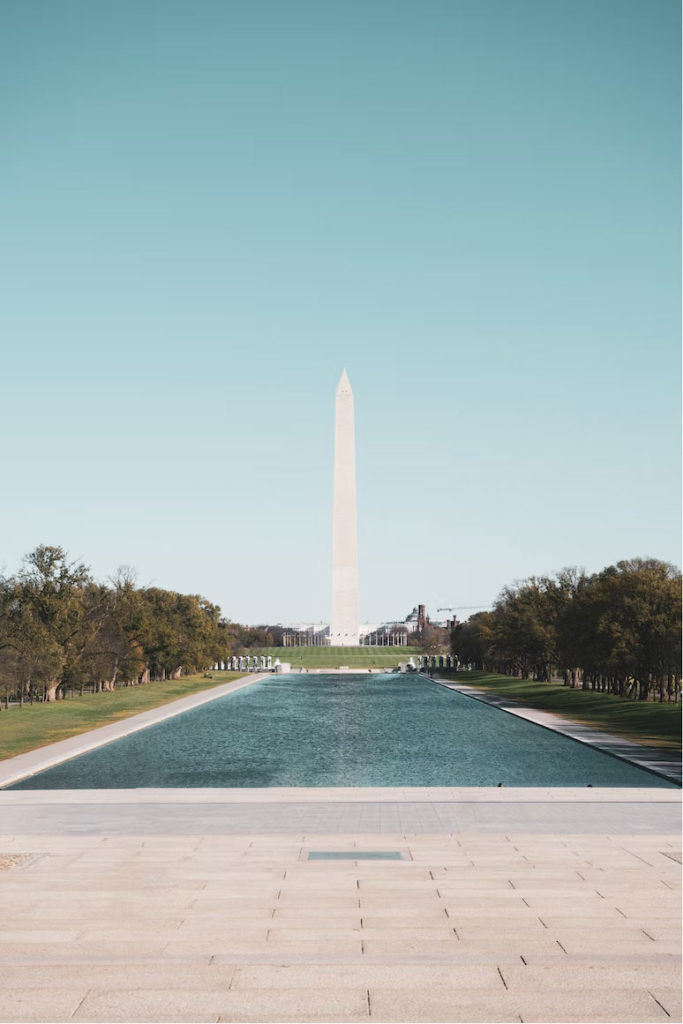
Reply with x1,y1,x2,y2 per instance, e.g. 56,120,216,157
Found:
430,676,681,786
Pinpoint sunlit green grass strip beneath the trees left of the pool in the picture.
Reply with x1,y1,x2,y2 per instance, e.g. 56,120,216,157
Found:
0,672,244,760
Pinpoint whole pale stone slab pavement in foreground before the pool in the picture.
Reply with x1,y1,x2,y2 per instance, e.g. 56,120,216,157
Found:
0,790,681,1022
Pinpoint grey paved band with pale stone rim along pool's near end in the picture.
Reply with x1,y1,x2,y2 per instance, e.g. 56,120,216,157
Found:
0,786,681,836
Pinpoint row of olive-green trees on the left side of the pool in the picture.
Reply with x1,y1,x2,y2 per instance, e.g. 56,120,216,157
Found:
0,545,259,706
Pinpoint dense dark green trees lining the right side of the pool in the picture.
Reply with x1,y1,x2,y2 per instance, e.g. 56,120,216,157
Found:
452,558,681,701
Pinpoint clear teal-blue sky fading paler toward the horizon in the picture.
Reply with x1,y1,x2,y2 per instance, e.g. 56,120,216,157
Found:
0,0,680,623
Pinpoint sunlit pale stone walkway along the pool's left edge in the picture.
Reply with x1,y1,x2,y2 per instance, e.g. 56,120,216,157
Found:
0,672,271,790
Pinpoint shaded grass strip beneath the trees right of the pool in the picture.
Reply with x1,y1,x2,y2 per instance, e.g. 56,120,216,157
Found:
438,671,681,750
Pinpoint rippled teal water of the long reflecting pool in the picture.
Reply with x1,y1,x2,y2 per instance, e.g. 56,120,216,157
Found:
11,674,674,790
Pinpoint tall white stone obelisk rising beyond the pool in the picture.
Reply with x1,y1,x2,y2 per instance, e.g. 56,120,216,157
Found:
330,370,358,647
